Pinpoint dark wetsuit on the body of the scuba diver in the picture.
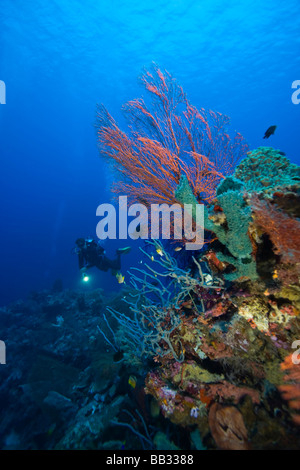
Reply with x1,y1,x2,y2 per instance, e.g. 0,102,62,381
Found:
77,240,121,271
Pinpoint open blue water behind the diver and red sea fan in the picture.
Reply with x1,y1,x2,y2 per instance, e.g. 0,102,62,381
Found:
0,0,300,304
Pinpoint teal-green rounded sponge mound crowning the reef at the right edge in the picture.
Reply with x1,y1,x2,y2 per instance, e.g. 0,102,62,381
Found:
234,147,300,193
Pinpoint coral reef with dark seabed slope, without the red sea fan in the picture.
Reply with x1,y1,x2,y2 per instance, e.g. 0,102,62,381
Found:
0,145,300,450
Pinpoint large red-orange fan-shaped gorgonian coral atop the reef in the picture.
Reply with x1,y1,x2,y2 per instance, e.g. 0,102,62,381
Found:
97,65,248,204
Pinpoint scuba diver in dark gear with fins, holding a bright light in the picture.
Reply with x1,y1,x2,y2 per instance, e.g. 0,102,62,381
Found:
75,238,130,283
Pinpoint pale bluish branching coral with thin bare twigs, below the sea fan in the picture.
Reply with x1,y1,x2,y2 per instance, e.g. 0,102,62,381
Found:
99,240,221,362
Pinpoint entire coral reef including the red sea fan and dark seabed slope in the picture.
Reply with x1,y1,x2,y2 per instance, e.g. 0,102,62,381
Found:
0,66,300,451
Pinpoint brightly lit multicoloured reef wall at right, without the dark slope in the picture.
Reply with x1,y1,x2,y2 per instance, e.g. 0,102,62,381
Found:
120,149,300,449
